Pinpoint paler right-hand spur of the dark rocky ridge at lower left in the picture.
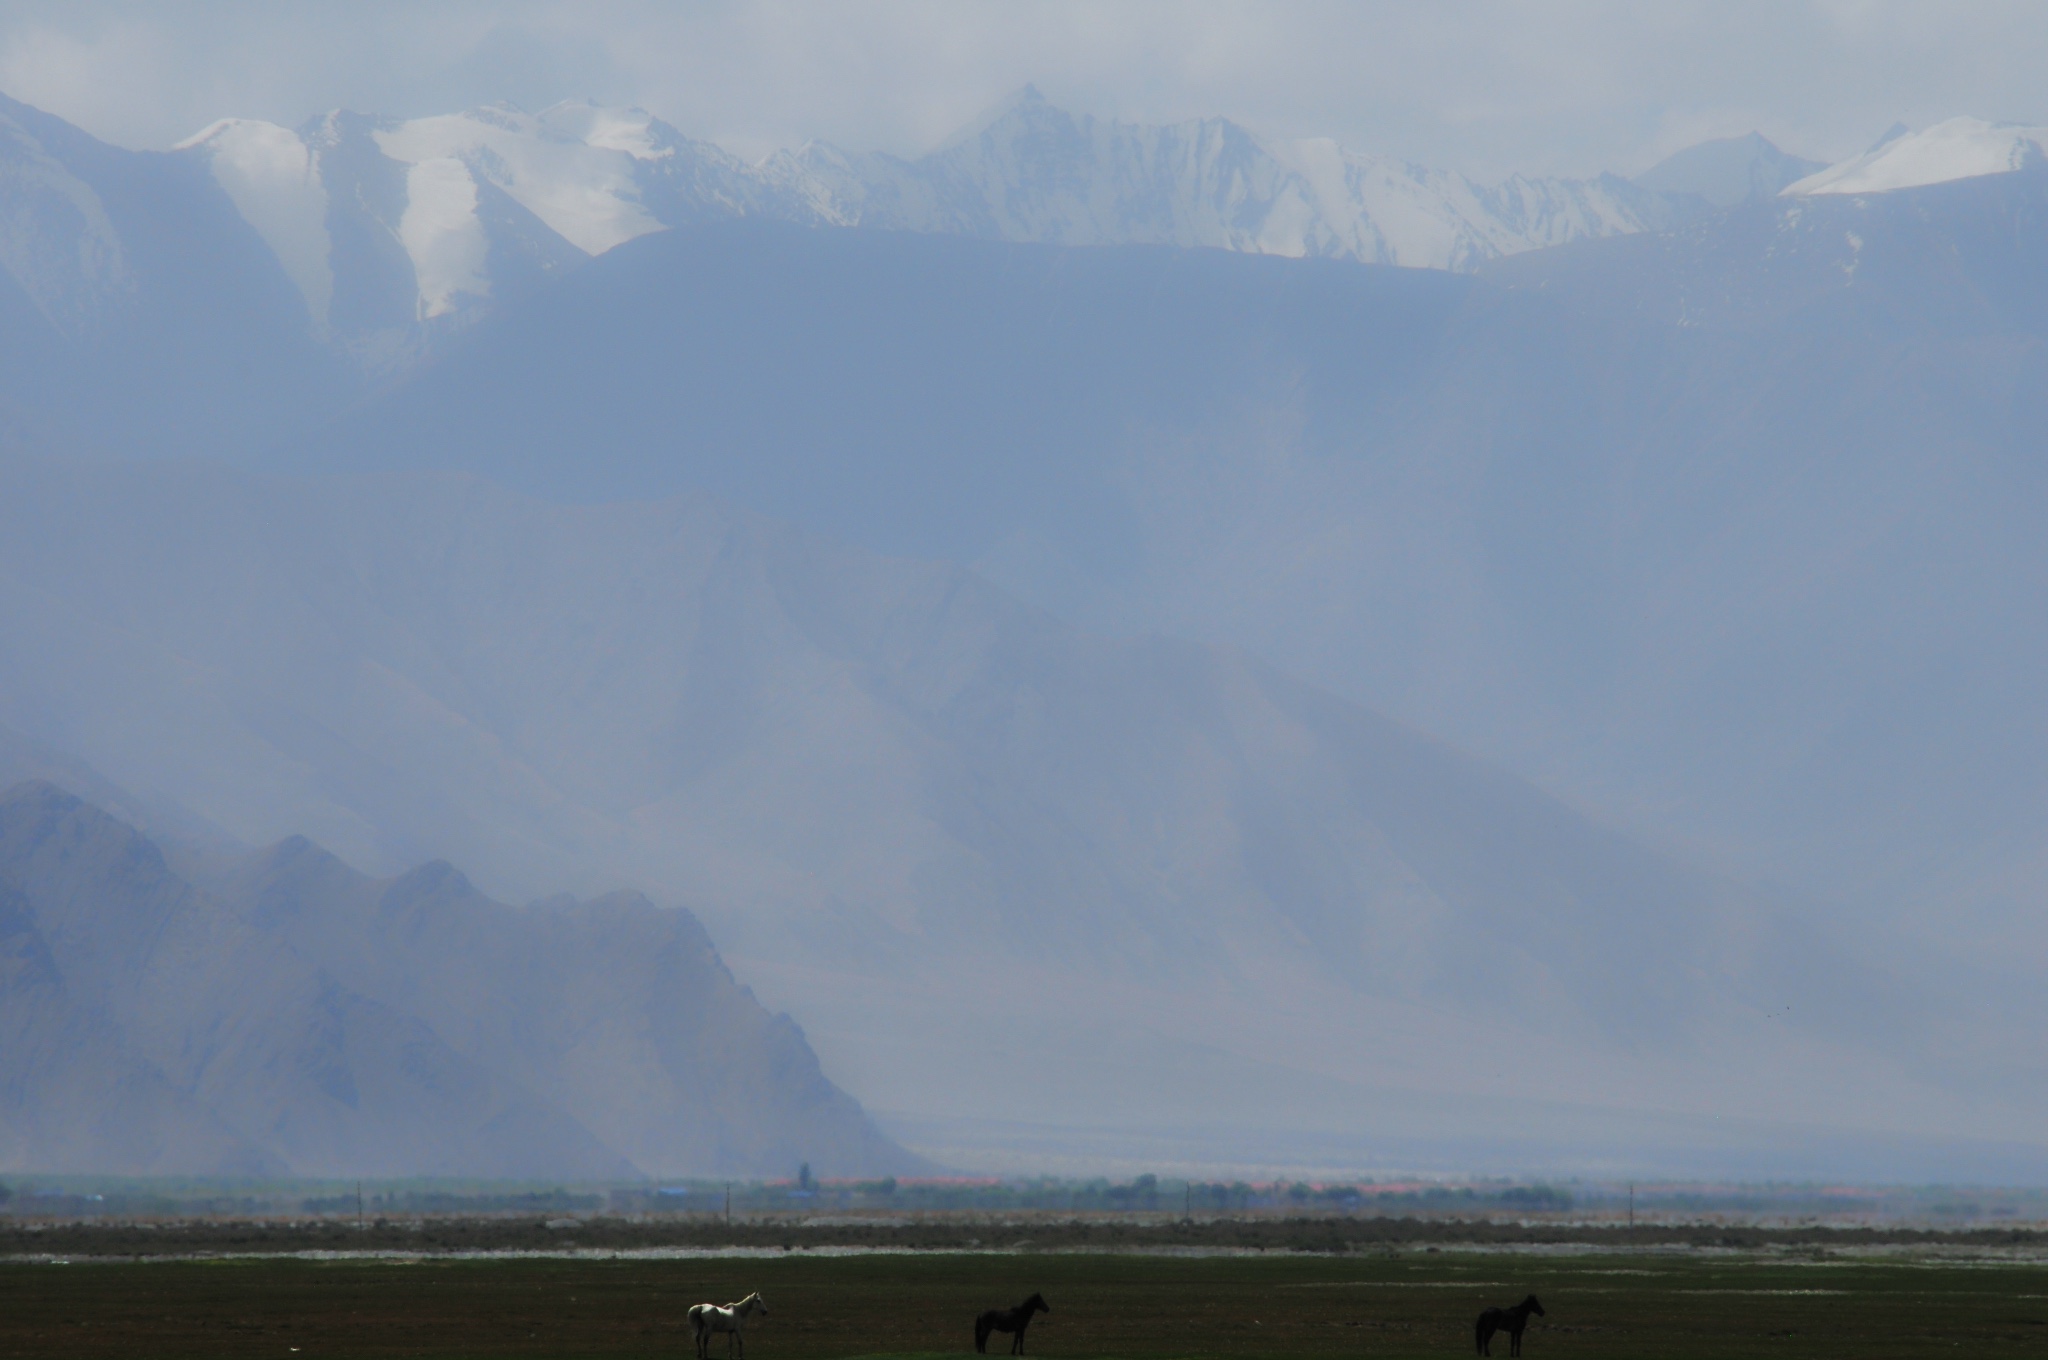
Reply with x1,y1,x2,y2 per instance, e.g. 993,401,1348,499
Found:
221,838,918,1176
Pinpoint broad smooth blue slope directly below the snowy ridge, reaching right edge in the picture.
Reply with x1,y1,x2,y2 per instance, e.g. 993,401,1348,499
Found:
299,170,2048,954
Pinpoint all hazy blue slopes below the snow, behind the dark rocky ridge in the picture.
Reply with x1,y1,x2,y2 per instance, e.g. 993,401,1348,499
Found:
0,90,2044,1174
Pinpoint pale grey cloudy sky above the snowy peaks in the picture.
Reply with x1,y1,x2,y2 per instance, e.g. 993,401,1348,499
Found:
0,0,2048,178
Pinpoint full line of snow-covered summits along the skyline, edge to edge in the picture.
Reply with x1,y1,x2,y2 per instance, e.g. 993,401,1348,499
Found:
16,88,2048,371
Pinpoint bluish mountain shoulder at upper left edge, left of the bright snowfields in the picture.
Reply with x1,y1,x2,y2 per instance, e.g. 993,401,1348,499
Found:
0,96,346,462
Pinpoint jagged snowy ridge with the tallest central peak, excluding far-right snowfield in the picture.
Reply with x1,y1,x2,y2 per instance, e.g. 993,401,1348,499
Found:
178,90,1686,348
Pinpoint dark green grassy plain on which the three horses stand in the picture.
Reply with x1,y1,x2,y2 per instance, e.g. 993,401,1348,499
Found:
0,1251,2048,1360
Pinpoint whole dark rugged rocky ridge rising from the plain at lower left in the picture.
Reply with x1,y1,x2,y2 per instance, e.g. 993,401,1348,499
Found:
0,782,915,1178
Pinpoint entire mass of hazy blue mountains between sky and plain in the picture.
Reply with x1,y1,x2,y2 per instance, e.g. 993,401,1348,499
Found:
0,34,2048,1182
